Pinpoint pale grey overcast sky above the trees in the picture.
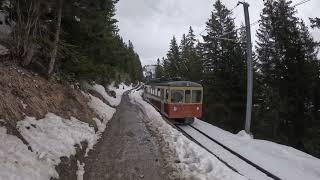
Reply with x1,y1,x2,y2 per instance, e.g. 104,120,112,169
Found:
116,0,320,65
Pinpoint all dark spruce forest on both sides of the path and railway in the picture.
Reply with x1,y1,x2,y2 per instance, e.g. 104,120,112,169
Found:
0,0,320,161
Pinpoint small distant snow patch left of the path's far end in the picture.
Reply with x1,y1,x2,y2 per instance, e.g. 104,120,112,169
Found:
92,83,133,106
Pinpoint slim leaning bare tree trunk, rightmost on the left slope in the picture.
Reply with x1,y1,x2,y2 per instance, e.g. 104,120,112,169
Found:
48,0,63,76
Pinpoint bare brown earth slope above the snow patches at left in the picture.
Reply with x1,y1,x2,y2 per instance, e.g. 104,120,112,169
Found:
0,62,95,128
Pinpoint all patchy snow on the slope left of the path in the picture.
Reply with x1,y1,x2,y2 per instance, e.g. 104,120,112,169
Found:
0,84,132,180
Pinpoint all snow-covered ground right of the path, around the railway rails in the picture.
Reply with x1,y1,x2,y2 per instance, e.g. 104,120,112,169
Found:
130,89,320,180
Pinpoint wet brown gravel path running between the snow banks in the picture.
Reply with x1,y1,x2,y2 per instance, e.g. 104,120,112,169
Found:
84,95,168,180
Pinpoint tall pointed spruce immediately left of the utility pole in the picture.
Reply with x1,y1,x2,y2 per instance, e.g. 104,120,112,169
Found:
203,0,246,132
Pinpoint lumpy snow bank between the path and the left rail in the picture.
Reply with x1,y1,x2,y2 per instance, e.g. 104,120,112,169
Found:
130,91,246,180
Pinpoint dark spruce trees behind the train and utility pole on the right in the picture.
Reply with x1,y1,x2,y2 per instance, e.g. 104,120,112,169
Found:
156,0,320,157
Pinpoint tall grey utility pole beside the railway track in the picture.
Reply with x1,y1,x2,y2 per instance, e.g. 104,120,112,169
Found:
238,2,253,134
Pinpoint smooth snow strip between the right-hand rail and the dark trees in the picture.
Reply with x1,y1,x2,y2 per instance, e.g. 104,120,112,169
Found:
193,120,320,180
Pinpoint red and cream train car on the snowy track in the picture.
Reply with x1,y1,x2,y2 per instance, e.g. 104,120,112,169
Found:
143,81,203,124
